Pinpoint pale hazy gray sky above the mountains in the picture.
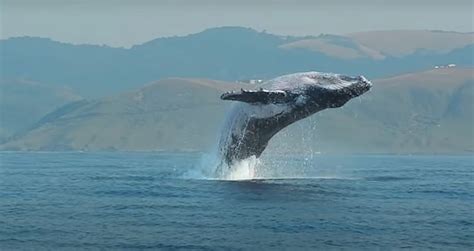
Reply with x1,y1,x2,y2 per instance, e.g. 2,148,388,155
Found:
0,0,474,47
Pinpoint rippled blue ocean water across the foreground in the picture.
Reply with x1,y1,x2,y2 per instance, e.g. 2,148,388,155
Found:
0,152,474,250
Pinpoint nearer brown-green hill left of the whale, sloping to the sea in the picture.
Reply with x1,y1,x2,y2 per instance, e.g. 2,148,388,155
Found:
0,78,237,150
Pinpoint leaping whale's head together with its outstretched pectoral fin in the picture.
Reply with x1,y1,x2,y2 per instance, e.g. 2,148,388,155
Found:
221,72,372,110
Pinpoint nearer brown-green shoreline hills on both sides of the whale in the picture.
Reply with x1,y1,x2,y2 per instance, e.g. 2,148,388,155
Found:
2,67,474,154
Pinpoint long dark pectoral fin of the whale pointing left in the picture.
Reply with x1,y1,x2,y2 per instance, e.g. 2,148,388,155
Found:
221,89,290,104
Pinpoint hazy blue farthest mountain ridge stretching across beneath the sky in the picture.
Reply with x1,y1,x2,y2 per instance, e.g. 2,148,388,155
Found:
0,27,474,98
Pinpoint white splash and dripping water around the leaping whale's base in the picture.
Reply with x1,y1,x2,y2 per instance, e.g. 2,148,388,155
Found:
184,108,316,181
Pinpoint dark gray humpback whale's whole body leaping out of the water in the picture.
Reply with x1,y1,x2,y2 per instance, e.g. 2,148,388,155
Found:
219,72,372,167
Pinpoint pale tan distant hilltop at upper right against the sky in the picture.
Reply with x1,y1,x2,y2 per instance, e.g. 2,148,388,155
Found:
281,30,474,61
